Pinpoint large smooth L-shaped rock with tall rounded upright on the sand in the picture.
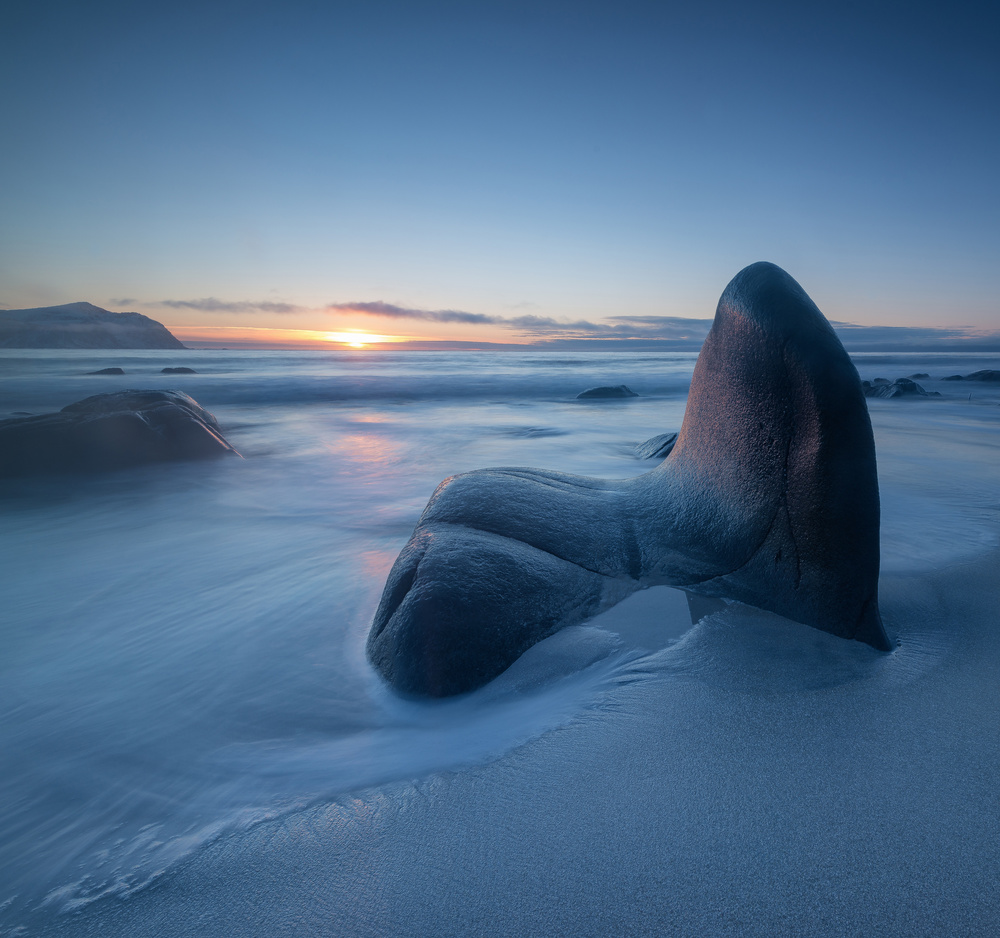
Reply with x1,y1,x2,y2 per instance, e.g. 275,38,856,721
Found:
367,263,890,696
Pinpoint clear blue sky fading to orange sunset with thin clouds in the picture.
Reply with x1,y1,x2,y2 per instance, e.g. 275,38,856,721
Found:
0,0,1000,347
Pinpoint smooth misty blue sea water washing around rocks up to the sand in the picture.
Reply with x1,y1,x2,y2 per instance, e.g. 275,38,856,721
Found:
0,350,1000,934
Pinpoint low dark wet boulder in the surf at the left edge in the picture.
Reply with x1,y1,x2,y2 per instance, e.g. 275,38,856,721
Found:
0,391,239,478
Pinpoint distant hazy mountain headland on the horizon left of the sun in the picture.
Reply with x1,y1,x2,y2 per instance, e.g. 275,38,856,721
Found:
0,303,186,348
